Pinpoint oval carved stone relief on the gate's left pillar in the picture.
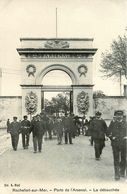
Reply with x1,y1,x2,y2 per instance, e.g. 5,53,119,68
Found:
25,91,38,114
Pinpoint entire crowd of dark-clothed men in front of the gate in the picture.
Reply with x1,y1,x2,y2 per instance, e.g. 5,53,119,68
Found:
7,111,127,180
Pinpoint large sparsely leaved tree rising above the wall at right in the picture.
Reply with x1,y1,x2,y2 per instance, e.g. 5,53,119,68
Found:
100,36,127,79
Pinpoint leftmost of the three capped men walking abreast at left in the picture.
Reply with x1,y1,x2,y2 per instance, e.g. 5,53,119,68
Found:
10,117,21,151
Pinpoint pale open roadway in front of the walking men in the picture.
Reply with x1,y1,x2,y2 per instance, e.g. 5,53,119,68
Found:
0,130,126,194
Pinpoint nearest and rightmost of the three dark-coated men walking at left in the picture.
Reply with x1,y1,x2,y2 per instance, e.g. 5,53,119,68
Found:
30,115,45,153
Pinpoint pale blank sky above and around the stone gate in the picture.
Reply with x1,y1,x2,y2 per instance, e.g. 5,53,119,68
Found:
0,0,127,96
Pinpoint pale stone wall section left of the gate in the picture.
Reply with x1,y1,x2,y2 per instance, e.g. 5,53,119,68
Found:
0,96,22,128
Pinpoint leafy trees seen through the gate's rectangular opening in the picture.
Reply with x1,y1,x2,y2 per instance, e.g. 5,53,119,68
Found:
45,92,70,115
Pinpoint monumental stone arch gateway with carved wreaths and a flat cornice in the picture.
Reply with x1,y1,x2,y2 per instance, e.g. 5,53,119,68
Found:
17,38,97,116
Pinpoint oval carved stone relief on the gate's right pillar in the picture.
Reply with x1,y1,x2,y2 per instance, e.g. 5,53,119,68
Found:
77,91,89,114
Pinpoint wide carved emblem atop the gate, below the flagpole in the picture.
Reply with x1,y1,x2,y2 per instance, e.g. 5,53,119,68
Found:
44,40,69,49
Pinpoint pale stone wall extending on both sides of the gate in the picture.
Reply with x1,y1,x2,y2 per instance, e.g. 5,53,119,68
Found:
0,96,127,128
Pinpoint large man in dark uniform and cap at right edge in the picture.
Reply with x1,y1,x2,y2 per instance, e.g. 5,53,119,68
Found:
108,111,127,180
